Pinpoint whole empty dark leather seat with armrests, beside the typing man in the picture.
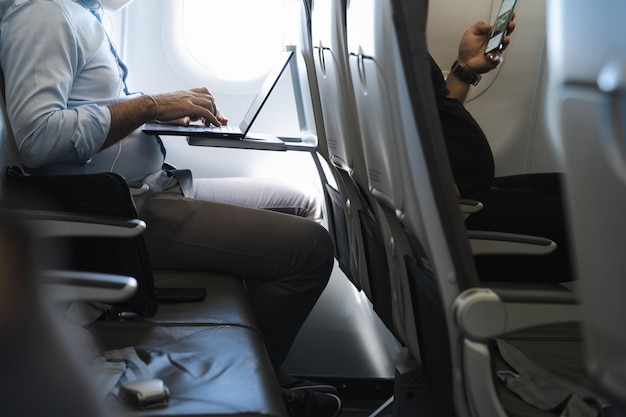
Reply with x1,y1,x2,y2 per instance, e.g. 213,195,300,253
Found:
0,72,287,417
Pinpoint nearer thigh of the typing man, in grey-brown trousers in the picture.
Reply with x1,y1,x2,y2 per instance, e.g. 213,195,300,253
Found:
141,194,332,280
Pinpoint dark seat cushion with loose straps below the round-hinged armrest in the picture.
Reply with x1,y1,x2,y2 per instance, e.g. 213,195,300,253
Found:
493,323,609,417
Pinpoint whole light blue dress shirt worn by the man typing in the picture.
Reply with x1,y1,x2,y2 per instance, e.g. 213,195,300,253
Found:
0,0,164,181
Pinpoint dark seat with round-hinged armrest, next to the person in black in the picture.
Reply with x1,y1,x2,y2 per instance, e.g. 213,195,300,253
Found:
368,0,610,417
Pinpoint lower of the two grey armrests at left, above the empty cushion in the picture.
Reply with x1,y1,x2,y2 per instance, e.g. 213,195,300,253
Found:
39,270,137,303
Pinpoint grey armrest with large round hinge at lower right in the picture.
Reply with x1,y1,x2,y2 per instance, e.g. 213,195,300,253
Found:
453,288,582,342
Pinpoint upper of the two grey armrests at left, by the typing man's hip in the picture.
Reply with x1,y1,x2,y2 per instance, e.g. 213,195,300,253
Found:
0,209,146,238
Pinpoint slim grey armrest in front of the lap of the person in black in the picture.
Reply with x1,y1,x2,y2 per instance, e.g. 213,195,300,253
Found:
467,230,556,255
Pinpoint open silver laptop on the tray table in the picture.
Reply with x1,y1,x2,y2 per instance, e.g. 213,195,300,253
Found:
142,51,293,139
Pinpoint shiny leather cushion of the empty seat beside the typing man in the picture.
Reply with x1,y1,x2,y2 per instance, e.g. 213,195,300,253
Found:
90,321,285,416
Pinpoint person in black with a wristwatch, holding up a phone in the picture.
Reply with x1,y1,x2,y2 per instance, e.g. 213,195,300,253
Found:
431,20,572,282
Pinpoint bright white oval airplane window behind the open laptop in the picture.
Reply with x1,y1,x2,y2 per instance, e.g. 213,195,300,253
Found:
182,0,299,81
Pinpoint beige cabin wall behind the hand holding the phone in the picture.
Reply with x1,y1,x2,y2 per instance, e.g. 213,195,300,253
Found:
427,0,560,175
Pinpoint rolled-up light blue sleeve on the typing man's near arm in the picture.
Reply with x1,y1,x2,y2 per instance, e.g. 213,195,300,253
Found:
0,2,111,168
